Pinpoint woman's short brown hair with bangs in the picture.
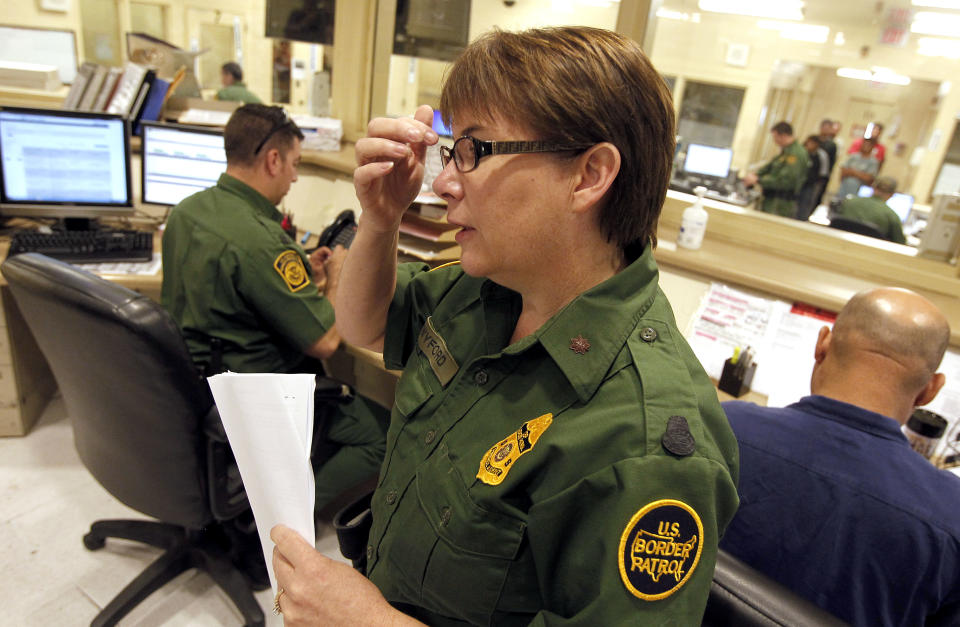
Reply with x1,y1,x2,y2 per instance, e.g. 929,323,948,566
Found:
440,27,676,253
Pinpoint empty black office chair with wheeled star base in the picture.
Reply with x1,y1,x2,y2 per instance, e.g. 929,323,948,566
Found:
0,253,266,626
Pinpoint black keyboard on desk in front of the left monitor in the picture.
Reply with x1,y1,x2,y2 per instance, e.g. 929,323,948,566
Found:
7,230,153,263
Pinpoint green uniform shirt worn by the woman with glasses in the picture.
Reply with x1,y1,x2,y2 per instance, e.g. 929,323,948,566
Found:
367,247,738,625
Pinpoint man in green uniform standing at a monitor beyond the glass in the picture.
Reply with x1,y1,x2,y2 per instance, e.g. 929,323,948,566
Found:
743,122,810,218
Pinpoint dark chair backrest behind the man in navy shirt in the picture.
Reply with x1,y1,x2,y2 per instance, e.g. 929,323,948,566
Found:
702,549,846,627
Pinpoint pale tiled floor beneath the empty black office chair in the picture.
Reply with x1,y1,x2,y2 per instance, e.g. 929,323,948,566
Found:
0,397,343,627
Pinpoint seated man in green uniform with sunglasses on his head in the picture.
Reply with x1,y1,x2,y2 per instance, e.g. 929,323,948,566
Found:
162,104,387,511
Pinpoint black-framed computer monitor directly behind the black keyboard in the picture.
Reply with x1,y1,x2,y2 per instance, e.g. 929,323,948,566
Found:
0,107,134,218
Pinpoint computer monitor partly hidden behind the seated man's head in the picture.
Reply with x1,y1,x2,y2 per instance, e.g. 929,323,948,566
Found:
141,122,227,205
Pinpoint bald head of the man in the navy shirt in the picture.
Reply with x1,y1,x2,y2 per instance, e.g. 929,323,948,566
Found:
832,287,950,391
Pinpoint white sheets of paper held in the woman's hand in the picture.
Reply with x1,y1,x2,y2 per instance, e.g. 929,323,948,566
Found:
208,372,316,594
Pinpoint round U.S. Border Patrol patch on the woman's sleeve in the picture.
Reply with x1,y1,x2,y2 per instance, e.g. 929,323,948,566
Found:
618,499,703,601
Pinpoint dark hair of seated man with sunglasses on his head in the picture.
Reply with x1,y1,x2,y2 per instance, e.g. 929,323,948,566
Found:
223,104,303,166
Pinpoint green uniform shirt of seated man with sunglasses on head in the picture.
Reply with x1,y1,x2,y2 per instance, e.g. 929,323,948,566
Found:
162,174,334,372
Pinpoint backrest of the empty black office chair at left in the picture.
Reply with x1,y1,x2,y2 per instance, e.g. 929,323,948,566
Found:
0,253,212,528
